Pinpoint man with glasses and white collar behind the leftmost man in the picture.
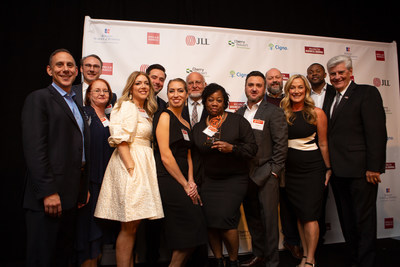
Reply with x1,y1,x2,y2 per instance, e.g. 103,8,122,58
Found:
72,54,117,110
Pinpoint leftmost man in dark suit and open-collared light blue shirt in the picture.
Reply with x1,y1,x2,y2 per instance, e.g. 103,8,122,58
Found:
22,49,89,266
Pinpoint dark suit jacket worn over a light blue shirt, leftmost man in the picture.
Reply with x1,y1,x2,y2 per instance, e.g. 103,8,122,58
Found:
22,85,90,211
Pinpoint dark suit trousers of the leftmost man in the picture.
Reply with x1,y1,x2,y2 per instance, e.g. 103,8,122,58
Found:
25,209,77,267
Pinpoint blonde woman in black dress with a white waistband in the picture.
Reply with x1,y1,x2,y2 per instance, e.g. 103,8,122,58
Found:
281,75,332,267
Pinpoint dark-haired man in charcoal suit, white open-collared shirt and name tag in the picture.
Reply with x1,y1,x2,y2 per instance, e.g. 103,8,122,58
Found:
237,71,288,267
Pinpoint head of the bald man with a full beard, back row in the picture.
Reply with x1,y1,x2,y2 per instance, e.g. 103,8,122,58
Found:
265,68,283,107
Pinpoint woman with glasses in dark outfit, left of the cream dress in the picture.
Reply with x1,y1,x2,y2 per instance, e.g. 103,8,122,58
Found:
75,79,118,266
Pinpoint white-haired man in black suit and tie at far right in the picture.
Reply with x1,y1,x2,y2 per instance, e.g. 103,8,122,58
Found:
327,55,387,266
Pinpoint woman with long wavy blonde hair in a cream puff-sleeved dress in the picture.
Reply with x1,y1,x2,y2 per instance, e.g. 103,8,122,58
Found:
94,71,164,266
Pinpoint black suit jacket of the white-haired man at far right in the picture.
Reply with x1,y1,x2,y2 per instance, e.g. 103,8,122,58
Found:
326,82,387,177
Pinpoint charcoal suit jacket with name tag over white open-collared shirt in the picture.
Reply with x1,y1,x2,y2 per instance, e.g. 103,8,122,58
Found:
236,99,288,186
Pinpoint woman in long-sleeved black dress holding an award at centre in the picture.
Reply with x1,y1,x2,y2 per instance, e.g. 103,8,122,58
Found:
193,83,257,266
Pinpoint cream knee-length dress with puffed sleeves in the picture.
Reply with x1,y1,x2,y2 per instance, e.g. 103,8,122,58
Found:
94,101,164,222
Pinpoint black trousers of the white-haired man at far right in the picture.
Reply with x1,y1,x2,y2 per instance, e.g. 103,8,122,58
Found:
331,175,378,267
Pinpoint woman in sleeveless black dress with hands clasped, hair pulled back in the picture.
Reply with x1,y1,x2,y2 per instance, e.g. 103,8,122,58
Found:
154,78,207,266
